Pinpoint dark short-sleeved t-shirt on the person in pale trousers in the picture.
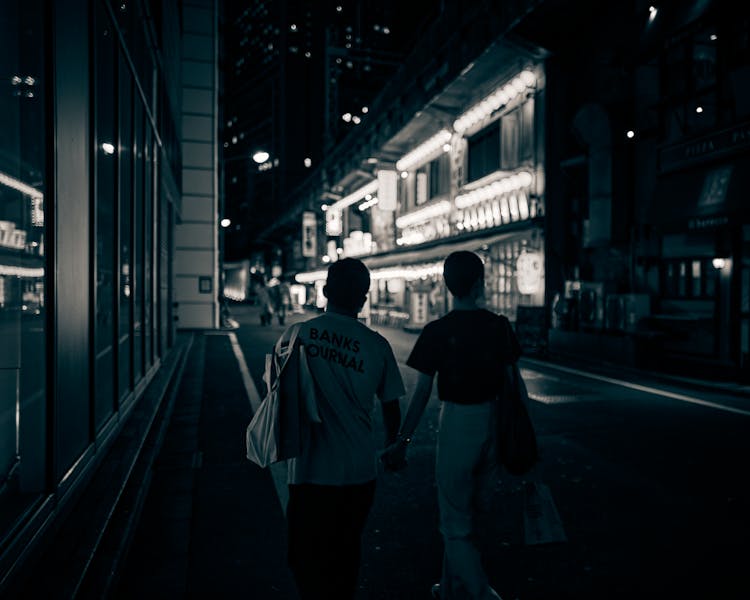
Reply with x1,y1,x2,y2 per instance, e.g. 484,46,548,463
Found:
406,309,521,404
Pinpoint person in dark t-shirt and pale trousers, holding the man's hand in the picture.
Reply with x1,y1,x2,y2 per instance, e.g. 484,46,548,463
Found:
385,251,521,600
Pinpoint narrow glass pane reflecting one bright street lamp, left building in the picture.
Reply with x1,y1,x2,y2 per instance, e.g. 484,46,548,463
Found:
94,3,117,429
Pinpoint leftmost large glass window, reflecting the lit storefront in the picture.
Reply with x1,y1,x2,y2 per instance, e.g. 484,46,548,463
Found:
0,0,47,534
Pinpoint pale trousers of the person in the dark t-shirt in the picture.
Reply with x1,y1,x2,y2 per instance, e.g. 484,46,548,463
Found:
435,402,500,600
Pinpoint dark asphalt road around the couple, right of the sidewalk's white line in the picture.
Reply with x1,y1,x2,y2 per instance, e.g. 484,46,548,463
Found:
232,306,750,600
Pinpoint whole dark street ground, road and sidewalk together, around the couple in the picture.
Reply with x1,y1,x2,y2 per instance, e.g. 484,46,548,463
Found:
108,305,750,600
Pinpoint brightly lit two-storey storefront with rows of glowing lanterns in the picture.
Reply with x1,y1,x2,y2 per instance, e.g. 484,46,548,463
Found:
297,54,545,329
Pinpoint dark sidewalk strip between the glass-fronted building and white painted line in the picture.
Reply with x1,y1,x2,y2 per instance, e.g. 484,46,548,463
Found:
113,324,297,600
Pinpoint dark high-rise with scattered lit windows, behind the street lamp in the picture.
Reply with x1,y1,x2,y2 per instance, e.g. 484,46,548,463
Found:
221,0,439,260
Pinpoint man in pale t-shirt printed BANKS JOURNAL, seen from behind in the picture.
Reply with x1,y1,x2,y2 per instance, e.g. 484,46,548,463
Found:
287,258,404,600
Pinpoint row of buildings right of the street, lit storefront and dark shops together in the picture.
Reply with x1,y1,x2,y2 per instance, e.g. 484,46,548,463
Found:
264,1,750,378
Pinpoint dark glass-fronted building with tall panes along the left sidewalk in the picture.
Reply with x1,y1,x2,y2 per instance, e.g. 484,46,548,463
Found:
0,0,217,594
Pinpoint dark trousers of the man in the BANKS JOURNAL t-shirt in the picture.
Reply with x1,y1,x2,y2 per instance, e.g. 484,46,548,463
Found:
286,480,375,600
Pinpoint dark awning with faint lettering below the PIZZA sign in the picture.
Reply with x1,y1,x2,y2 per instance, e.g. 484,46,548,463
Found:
646,159,750,230
